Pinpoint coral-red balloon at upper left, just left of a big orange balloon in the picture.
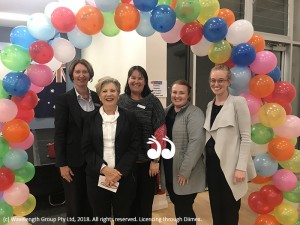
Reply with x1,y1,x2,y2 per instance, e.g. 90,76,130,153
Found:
51,7,76,33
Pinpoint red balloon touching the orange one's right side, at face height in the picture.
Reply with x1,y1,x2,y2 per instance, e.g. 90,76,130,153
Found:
272,81,296,102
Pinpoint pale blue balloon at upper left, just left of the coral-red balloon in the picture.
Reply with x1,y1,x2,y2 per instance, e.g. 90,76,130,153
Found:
27,13,56,41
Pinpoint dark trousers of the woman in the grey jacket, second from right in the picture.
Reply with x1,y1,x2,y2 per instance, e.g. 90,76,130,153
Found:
166,183,197,225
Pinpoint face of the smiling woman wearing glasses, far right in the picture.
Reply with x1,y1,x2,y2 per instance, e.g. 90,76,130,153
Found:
209,70,230,95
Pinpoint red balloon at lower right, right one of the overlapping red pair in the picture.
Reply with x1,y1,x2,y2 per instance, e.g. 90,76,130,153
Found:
259,185,283,208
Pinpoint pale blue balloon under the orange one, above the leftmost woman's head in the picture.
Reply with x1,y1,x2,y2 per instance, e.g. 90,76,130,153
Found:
67,26,93,49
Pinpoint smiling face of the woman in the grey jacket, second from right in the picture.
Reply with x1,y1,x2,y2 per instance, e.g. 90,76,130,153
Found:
171,84,190,108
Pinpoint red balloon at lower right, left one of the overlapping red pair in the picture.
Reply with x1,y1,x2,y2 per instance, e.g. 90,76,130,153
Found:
248,191,273,214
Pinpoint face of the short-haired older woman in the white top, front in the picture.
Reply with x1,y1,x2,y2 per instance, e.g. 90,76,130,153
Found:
99,83,120,107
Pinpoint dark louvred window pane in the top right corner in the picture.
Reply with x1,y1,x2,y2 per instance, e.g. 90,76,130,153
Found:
253,0,288,35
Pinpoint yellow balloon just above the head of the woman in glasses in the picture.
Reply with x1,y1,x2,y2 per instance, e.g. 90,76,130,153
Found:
208,40,231,64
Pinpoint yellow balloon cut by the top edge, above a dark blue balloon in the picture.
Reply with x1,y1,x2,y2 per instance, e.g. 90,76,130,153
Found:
197,0,220,25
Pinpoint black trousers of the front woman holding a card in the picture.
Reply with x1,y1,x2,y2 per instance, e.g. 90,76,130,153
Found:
87,174,136,225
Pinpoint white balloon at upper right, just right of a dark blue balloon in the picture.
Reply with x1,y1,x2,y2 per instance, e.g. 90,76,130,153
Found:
226,20,254,46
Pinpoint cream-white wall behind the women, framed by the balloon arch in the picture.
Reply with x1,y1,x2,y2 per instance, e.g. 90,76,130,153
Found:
82,31,167,105
